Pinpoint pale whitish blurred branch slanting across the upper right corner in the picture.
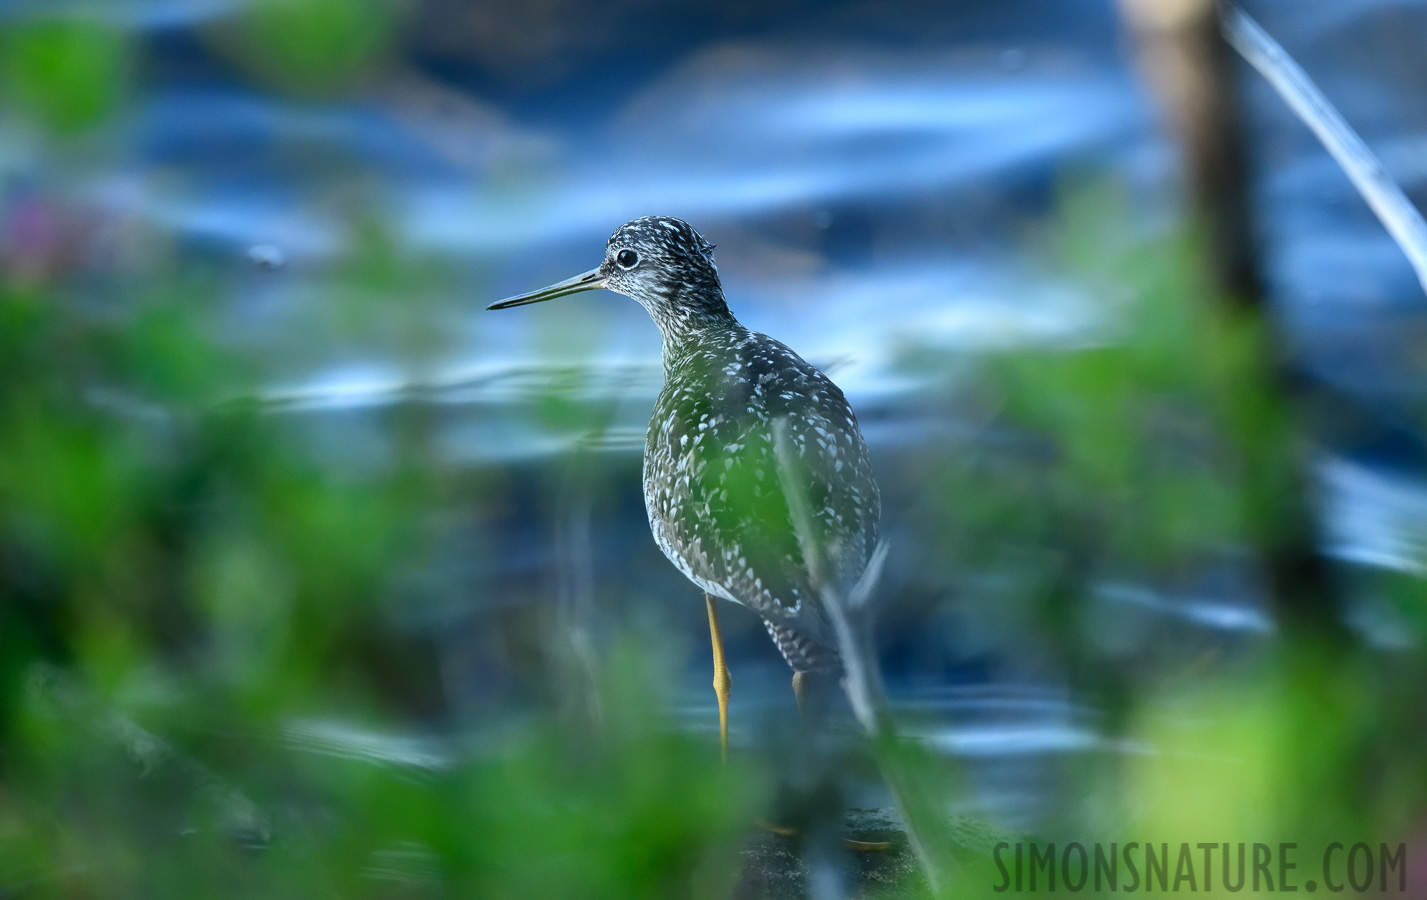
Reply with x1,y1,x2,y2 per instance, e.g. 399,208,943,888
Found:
1223,3,1427,298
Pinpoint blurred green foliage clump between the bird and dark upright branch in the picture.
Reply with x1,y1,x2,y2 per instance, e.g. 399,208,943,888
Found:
909,184,1299,676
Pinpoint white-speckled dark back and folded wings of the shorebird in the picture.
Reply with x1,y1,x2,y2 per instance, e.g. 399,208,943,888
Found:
645,332,880,646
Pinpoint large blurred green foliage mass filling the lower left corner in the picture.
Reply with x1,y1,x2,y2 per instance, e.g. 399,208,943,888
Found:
0,253,765,897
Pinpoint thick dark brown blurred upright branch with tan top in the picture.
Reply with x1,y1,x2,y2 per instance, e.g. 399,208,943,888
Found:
1120,0,1343,640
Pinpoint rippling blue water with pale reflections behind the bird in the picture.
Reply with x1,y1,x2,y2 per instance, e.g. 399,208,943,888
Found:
0,0,1427,824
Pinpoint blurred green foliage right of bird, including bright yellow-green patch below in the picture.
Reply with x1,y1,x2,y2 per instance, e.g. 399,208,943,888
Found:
909,184,1427,877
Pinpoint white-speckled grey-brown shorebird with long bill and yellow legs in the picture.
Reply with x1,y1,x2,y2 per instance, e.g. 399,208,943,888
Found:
488,215,882,760
